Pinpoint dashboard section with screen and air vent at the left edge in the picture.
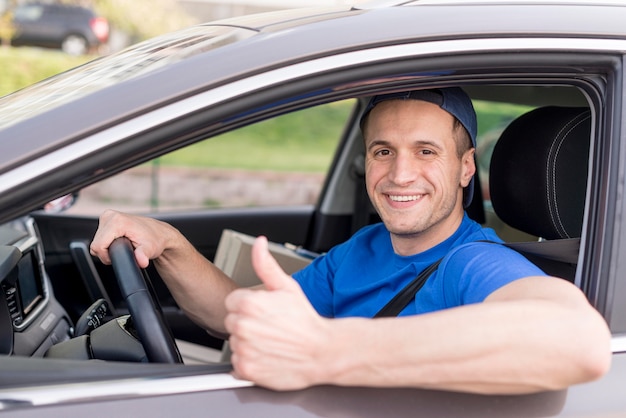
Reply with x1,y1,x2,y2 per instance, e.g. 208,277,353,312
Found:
0,217,72,356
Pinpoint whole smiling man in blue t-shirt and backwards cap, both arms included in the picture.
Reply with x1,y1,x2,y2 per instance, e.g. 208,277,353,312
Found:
91,88,611,393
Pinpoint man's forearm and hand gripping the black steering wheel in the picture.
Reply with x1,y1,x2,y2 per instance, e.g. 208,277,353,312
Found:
90,210,237,334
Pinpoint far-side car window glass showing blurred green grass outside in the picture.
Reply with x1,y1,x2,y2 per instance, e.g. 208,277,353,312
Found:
70,101,354,215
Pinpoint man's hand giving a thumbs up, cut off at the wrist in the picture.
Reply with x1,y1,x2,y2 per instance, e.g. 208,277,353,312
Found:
224,237,331,390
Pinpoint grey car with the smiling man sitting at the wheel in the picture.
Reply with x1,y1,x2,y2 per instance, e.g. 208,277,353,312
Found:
0,0,626,417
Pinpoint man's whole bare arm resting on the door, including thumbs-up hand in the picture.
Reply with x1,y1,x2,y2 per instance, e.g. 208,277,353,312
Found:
226,240,611,393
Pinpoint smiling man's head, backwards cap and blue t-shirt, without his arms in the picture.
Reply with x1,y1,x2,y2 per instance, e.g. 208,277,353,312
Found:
294,88,560,317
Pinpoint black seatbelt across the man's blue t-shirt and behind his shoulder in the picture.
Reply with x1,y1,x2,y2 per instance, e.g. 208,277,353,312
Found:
374,238,580,318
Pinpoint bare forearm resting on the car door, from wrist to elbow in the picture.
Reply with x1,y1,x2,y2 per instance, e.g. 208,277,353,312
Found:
325,280,610,393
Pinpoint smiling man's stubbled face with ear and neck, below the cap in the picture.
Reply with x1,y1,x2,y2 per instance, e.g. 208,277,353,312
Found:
364,100,475,255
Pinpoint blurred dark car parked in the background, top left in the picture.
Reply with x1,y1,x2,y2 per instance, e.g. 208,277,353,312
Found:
11,3,109,55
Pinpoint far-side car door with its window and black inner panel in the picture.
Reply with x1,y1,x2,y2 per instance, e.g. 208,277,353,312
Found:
33,101,354,346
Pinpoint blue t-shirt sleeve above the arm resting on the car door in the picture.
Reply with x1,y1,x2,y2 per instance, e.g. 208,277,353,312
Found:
440,243,547,306
